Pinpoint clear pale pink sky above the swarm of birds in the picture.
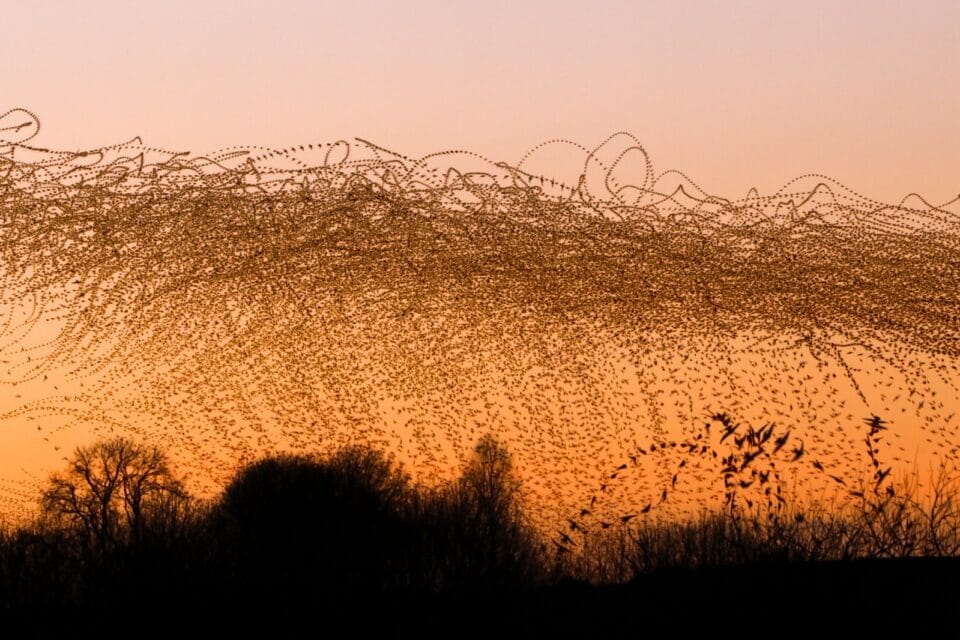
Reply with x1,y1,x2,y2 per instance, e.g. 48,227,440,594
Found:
0,0,960,203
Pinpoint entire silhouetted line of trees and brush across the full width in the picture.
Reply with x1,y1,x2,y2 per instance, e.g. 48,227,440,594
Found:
0,432,960,632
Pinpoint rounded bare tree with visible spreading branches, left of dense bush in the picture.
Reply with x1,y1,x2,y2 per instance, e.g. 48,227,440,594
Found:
41,438,186,553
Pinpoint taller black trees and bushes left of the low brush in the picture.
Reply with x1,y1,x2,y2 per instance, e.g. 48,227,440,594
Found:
0,438,546,619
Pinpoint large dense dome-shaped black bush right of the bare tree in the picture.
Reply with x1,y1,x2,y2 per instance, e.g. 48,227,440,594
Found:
211,448,407,601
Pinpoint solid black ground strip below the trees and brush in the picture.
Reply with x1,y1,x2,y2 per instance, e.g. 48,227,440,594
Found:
11,559,960,638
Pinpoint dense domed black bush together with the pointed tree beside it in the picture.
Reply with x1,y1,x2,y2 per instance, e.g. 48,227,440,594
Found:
211,438,539,602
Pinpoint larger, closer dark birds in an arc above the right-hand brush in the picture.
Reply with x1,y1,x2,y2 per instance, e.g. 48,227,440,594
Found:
552,412,897,555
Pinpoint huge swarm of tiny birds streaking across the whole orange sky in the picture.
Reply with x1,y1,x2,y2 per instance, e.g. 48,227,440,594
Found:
0,109,960,522
